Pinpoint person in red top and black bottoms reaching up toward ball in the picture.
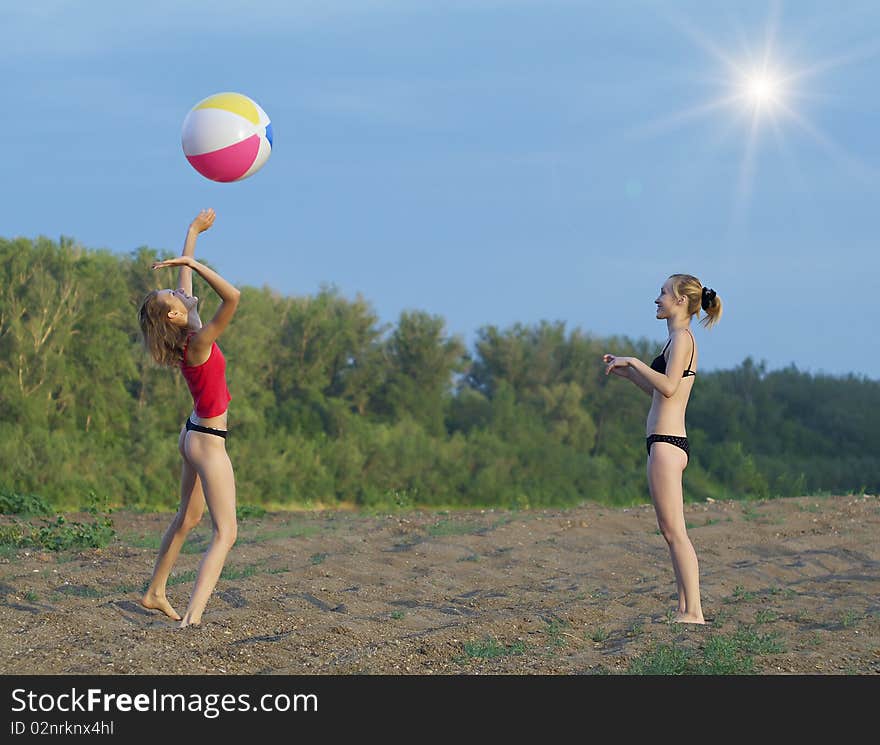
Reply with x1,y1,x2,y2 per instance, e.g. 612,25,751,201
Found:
140,209,240,628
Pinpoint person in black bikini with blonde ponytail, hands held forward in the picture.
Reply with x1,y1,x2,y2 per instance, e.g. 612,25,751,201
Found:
603,274,721,623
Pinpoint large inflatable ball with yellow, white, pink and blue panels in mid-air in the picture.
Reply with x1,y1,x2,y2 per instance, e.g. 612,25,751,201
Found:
181,93,272,182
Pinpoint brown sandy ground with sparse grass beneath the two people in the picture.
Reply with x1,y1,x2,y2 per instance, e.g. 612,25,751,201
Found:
0,495,880,675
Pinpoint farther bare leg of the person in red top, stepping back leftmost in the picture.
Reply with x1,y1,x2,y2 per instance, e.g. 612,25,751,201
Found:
141,424,205,621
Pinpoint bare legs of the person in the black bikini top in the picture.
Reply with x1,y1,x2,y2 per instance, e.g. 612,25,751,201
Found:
648,442,705,623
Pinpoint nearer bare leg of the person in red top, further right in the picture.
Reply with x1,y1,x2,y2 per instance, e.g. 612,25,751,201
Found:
180,432,238,628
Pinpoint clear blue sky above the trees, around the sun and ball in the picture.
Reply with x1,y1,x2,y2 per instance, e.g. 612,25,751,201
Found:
0,0,880,379
